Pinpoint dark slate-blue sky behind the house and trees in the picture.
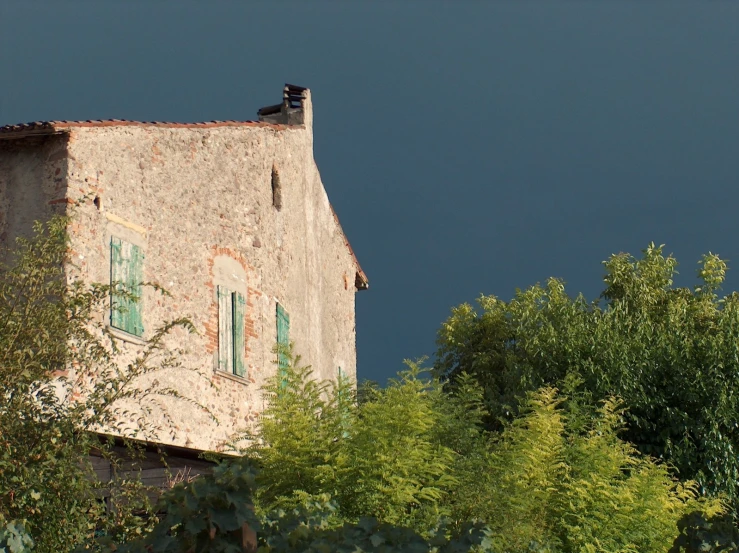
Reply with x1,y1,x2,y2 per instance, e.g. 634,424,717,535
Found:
0,0,739,381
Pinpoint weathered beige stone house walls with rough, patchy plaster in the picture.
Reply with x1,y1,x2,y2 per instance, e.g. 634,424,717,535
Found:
0,84,367,449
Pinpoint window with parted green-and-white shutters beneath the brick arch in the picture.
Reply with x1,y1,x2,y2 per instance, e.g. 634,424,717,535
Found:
218,286,246,376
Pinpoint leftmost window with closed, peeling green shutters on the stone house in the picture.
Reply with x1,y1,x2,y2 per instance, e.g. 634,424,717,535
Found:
110,236,144,336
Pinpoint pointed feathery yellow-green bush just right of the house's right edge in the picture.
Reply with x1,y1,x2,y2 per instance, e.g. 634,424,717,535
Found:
344,362,455,528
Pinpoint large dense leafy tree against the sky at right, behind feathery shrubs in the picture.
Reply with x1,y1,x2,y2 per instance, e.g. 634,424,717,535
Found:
435,244,739,503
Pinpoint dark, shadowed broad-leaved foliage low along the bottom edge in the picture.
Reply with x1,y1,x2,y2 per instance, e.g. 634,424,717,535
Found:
98,458,487,553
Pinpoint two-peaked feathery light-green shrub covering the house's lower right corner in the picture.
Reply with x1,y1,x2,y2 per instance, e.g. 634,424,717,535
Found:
247,354,456,529
